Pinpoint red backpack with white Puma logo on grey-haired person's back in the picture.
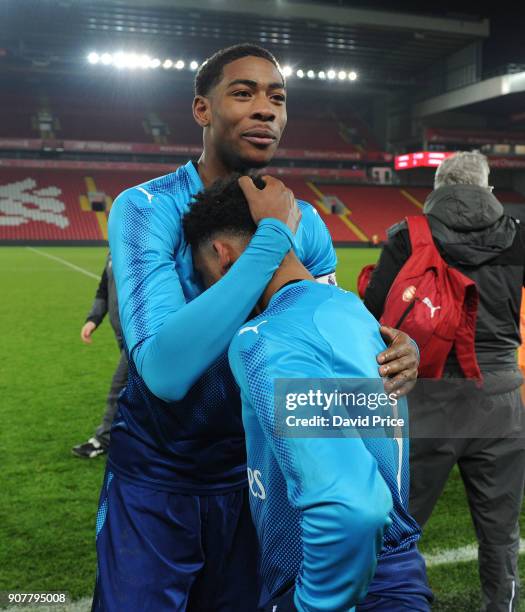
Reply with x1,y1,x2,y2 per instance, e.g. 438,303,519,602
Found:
381,216,482,384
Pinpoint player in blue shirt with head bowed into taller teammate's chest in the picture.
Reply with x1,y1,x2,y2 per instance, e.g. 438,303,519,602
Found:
183,176,431,612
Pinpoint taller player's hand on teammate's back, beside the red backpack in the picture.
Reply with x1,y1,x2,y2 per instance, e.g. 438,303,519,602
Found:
377,325,419,396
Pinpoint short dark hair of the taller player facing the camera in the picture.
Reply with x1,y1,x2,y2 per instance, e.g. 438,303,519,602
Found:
194,43,284,96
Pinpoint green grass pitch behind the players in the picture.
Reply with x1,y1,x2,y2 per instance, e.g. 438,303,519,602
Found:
0,247,523,612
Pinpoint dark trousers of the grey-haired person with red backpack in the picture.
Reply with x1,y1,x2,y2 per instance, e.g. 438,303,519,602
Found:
409,387,525,612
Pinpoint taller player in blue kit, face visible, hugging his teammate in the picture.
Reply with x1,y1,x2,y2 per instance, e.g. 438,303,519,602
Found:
93,45,418,612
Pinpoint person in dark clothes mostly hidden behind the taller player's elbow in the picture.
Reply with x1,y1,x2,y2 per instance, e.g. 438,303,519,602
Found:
71,254,128,459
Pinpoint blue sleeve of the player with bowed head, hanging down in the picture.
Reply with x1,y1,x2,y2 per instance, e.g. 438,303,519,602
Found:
229,334,392,612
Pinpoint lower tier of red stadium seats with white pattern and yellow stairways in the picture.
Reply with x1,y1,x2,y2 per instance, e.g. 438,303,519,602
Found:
0,166,525,243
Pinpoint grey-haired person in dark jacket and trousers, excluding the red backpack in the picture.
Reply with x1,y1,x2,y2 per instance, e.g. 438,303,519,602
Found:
365,152,525,611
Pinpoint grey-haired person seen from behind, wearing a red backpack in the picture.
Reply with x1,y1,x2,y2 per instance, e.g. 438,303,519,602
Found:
361,152,525,612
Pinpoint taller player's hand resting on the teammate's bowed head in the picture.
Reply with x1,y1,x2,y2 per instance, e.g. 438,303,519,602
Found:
239,175,301,234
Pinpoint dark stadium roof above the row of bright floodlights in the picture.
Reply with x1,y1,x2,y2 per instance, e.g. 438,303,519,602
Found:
0,0,489,87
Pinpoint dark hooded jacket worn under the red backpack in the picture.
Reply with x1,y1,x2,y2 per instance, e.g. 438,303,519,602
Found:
365,185,525,386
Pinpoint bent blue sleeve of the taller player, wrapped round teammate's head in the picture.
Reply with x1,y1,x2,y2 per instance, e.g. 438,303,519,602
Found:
109,189,294,401
